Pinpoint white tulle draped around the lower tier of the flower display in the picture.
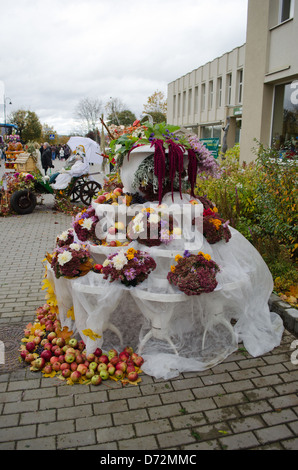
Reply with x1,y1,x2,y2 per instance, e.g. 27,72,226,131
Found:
48,190,283,379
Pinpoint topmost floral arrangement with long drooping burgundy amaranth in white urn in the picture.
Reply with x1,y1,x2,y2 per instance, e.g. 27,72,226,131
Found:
110,122,219,203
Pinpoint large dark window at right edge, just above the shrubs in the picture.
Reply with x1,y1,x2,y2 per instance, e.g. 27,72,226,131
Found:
272,83,298,152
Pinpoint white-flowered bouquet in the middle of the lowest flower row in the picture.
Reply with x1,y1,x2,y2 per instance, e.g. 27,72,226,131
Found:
101,248,156,286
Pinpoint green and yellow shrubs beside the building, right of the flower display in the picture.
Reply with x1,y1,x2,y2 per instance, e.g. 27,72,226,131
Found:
196,144,298,293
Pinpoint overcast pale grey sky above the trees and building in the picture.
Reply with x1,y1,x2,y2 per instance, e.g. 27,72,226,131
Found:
0,0,247,134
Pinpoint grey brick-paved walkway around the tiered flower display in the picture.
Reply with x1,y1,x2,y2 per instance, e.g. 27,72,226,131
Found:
0,162,298,455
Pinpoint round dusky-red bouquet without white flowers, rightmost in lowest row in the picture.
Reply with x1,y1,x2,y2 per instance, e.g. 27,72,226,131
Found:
167,250,220,295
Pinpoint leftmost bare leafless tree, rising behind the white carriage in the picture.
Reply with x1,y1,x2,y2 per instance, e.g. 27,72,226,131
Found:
75,98,102,134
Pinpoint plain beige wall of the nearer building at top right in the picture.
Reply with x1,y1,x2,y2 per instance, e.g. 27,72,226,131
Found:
240,0,298,162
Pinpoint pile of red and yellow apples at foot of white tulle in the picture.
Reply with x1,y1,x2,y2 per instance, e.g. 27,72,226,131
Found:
21,305,144,385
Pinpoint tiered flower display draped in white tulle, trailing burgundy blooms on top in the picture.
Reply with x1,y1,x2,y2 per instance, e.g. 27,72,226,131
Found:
19,122,283,386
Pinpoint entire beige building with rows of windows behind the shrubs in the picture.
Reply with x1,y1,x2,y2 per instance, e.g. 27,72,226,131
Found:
167,0,298,162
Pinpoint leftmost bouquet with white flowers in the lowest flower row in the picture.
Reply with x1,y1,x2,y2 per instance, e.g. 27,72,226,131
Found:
46,243,93,279
